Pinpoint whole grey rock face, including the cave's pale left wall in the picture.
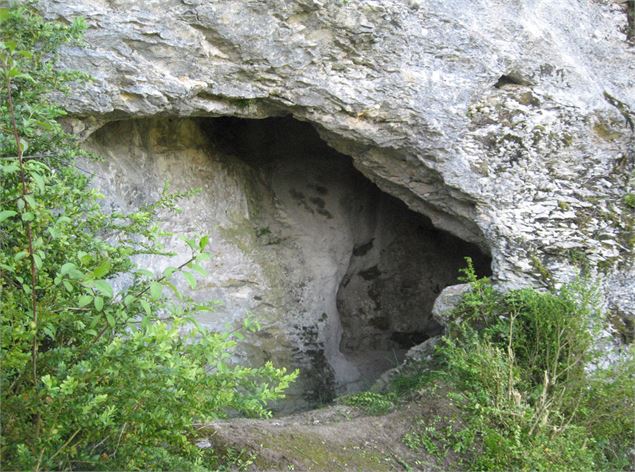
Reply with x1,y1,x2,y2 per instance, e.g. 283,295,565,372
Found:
41,0,635,410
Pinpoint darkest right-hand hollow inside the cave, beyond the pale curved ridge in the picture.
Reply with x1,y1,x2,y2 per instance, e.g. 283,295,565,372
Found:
337,189,491,391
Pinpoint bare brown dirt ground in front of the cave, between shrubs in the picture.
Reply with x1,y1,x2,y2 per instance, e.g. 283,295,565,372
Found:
200,402,439,472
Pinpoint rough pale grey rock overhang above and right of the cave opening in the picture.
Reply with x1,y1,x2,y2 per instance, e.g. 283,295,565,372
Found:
42,0,635,406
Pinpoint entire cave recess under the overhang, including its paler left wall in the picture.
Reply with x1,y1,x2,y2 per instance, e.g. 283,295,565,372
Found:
86,117,491,412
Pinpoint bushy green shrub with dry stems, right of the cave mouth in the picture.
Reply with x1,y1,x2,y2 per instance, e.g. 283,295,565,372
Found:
404,260,635,471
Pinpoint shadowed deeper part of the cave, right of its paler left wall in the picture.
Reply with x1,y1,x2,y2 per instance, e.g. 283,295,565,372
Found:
203,118,491,396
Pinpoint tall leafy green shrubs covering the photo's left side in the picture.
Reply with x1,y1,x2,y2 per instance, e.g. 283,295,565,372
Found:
0,5,295,470
